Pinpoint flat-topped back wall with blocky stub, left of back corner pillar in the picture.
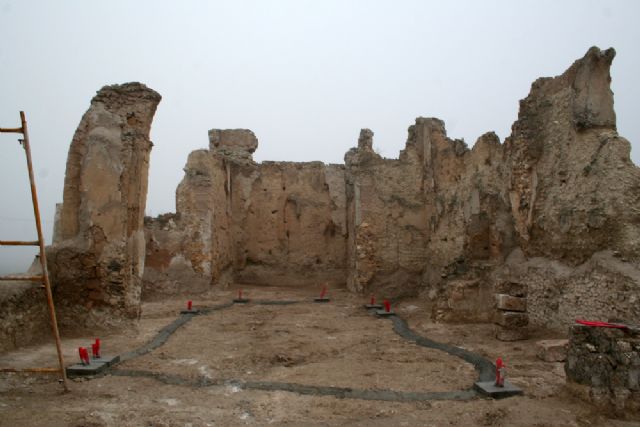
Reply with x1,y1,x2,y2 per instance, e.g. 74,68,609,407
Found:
144,129,347,297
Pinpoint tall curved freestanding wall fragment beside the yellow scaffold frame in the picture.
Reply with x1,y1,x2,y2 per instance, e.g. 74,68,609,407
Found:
47,83,161,326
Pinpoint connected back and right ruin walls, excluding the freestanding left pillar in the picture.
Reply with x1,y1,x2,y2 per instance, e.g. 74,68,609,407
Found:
145,48,640,331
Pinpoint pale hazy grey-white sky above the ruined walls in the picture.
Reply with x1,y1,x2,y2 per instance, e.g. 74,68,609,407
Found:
0,0,640,273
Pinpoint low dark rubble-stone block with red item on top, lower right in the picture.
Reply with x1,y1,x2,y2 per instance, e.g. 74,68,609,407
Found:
565,325,640,411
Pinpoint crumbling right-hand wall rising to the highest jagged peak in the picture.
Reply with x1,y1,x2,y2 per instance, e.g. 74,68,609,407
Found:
345,48,640,329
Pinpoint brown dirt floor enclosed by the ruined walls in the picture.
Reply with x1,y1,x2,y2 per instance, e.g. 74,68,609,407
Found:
0,287,640,427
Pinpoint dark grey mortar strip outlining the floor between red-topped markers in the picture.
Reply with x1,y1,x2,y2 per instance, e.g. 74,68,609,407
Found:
99,300,504,402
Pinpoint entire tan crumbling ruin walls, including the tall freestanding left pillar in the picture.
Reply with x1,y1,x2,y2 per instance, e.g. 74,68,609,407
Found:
0,48,640,352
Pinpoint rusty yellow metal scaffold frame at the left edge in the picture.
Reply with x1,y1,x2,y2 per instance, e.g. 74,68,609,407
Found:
0,111,69,391
